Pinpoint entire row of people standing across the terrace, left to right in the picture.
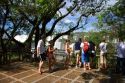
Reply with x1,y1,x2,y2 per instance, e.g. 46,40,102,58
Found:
37,37,125,73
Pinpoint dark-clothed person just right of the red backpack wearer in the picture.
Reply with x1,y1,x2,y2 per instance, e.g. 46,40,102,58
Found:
89,41,96,68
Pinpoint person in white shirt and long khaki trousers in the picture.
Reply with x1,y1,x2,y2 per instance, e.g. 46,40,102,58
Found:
99,39,107,69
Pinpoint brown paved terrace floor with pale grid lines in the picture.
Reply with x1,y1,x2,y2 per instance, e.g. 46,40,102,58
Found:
0,62,123,83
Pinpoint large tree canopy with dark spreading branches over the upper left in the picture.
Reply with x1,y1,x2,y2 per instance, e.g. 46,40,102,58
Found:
0,0,105,63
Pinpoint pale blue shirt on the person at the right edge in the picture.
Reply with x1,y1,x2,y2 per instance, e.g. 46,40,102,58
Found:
116,42,125,58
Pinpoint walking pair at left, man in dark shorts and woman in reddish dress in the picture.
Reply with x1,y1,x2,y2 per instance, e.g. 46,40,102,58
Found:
37,38,56,73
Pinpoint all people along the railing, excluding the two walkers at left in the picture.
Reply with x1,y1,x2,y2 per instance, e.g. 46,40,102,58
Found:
65,37,125,75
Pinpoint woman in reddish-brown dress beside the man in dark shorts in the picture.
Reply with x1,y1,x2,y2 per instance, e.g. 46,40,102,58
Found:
47,41,56,73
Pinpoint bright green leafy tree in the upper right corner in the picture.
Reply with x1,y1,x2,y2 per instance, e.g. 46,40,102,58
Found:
95,0,125,38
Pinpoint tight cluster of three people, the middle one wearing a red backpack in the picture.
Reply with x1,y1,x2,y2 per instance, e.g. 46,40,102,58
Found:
71,37,96,70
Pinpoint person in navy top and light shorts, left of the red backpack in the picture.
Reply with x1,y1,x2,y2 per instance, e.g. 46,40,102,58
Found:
74,38,82,68
